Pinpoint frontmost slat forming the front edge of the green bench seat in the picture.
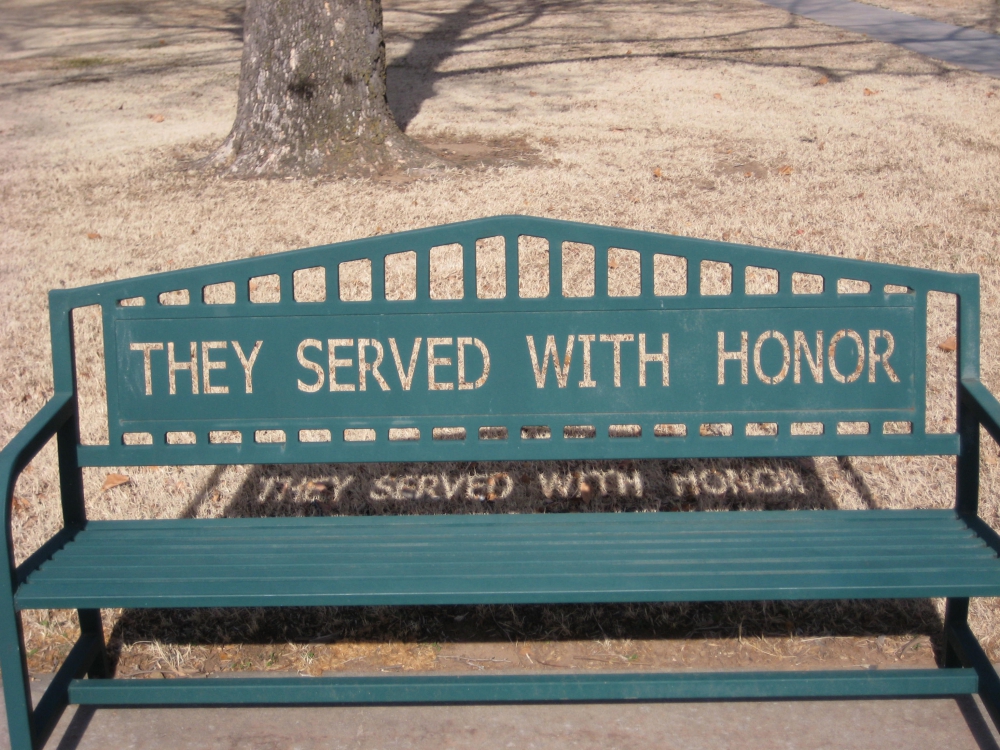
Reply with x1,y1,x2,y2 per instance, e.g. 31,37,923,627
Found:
17,576,1000,609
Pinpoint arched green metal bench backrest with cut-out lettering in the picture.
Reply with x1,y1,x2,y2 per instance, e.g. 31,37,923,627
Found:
50,216,979,465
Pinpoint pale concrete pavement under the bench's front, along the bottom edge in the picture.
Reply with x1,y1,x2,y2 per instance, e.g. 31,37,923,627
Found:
0,682,1000,750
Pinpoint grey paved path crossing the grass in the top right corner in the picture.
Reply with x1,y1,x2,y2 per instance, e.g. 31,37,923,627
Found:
761,0,1000,78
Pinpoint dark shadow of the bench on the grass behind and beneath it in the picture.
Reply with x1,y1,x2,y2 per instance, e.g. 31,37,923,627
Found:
110,458,942,680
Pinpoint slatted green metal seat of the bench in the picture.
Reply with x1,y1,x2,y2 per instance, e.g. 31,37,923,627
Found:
16,510,1000,609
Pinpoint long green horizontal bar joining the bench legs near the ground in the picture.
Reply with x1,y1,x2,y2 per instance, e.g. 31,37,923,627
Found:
69,669,978,706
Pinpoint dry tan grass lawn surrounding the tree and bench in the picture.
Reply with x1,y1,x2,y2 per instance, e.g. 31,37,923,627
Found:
0,0,1000,675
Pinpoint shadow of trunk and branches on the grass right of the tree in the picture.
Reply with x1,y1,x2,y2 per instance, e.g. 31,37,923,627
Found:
386,0,953,130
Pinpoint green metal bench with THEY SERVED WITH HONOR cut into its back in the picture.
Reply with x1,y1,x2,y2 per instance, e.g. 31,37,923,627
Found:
0,216,1000,750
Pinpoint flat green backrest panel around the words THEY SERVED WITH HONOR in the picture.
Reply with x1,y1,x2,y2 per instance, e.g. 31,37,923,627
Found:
116,307,916,424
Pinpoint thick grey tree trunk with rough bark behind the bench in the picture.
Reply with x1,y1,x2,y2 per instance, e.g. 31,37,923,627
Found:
206,0,439,177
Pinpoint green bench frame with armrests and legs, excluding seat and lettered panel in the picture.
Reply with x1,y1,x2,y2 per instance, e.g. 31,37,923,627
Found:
0,216,1000,750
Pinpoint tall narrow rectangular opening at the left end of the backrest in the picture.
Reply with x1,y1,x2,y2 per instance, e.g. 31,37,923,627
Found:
72,305,110,445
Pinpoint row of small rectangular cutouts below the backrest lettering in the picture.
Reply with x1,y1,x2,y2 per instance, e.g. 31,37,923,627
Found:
122,421,913,446
